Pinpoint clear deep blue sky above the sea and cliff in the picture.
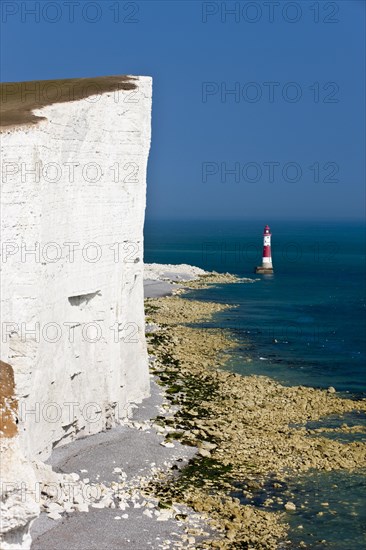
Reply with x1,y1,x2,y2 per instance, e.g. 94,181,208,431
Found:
1,0,365,220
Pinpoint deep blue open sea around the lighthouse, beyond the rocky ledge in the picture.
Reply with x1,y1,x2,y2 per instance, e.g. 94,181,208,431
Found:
145,220,366,396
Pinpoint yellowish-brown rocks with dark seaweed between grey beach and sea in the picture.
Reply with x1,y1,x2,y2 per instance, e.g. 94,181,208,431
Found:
146,292,366,549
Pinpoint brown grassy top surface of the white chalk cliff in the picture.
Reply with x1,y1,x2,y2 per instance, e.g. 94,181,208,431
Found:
0,75,136,129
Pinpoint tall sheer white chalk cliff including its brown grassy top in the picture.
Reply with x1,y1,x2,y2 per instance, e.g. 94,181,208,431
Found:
1,77,152,548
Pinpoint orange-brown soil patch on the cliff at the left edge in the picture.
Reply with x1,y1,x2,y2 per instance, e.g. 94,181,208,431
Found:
0,361,18,438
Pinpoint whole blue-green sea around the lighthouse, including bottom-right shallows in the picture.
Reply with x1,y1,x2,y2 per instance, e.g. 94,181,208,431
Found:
144,219,366,550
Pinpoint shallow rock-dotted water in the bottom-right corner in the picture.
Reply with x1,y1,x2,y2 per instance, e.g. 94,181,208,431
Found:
233,470,366,550
